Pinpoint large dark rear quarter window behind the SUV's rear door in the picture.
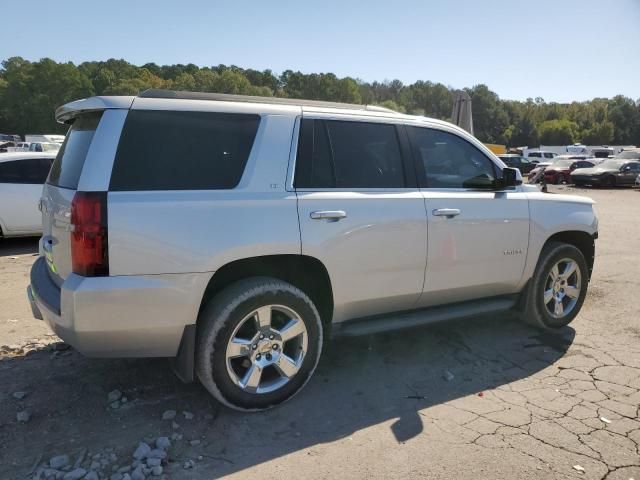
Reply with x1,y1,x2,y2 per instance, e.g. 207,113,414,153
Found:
109,110,260,191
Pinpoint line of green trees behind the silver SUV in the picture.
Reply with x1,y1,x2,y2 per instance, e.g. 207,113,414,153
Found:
0,57,640,146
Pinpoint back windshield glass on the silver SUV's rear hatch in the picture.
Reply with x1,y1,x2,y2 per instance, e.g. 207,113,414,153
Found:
47,112,102,190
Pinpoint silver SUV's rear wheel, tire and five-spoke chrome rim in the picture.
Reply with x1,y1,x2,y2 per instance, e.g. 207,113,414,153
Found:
196,277,322,411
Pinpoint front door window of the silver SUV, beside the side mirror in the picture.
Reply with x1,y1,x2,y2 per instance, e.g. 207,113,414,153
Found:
407,127,496,188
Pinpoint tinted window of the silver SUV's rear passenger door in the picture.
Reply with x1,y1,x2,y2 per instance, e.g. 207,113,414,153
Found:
295,119,406,188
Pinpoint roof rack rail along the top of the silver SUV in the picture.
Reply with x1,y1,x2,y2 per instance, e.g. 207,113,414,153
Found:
138,88,398,113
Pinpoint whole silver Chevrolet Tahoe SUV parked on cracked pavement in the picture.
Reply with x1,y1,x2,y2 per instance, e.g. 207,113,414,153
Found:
28,91,597,410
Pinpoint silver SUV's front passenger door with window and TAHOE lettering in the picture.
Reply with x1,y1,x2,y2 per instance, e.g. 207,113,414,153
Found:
407,126,529,306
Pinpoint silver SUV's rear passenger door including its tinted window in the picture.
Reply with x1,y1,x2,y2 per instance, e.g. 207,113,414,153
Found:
294,117,427,322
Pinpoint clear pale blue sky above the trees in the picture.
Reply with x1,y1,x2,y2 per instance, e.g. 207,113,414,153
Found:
0,0,640,102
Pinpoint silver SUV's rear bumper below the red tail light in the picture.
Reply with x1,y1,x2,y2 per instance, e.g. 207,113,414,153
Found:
27,257,211,357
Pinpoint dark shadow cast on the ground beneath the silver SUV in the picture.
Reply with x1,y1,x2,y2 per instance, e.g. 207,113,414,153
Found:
0,317,575,478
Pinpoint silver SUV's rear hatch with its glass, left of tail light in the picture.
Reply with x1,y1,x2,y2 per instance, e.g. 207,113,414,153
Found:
40,111,103,286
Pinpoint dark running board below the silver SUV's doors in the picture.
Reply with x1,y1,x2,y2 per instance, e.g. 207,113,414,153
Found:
331,295,518,337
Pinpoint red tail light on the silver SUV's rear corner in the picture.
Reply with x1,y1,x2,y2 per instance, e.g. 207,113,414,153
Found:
71,192,109,277
